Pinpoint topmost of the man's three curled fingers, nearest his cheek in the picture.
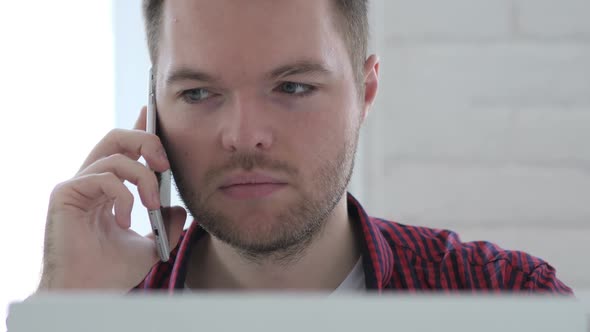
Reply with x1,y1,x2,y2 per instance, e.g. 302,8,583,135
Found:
80,129,170,172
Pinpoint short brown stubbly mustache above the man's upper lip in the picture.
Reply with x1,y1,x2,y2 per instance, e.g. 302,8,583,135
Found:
205,153,298,180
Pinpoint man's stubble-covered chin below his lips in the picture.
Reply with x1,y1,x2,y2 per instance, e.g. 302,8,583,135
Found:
185,184,326,253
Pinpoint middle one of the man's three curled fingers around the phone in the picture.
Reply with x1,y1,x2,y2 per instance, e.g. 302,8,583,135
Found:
78,154,160,210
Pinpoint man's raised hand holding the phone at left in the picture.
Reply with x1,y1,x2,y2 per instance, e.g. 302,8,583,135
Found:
39,107,186,291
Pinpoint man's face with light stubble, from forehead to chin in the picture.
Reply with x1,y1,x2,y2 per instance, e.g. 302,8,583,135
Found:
157,0,362,254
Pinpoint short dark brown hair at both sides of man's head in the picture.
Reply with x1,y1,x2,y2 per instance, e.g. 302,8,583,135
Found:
142,0,369,85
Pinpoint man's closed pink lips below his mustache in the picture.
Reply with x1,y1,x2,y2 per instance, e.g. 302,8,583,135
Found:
219,173,287,200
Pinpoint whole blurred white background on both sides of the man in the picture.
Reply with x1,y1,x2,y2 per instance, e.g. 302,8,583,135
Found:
0,0,590,326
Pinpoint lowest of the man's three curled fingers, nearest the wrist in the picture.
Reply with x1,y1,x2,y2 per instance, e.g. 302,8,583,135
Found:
56,173,133,228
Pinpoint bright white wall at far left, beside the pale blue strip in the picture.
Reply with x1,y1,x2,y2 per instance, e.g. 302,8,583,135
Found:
0,0,114,331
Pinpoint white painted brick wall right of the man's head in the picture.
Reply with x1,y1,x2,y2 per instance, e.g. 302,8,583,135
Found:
355,0,590,288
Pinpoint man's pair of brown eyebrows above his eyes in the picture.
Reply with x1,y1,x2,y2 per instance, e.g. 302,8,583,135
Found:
165,60,332,86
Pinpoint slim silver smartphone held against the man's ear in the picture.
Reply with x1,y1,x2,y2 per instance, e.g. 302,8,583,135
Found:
146,68,171,262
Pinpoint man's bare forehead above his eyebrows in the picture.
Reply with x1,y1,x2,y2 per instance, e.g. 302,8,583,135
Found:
158,0,346,79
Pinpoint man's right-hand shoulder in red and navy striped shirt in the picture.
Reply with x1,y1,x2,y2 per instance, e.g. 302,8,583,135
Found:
371,218,571,293
